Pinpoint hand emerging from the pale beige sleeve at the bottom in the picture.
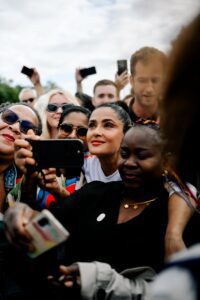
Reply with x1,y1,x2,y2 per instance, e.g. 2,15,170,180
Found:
48,264,81,289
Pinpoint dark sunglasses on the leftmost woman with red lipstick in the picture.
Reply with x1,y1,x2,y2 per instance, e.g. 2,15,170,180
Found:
1,109,40,134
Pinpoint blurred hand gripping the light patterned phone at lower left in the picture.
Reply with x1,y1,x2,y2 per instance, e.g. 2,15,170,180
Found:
4,203,38,251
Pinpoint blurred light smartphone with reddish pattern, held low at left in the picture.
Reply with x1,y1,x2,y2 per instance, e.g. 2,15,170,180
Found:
26,209,70,258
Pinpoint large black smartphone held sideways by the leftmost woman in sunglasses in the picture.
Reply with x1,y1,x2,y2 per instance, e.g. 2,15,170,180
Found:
26,139,84,175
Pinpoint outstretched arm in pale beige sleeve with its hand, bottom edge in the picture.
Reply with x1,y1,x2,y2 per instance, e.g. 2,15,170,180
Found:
48,261,156,300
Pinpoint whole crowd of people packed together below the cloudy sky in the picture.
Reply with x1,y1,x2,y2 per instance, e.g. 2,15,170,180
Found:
0,15,200,300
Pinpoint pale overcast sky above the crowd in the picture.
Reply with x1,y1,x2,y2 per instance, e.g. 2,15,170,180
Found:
0,0,200,94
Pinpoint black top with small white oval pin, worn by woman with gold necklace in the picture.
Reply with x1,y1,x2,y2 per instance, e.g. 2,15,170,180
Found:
52,181,168,271
